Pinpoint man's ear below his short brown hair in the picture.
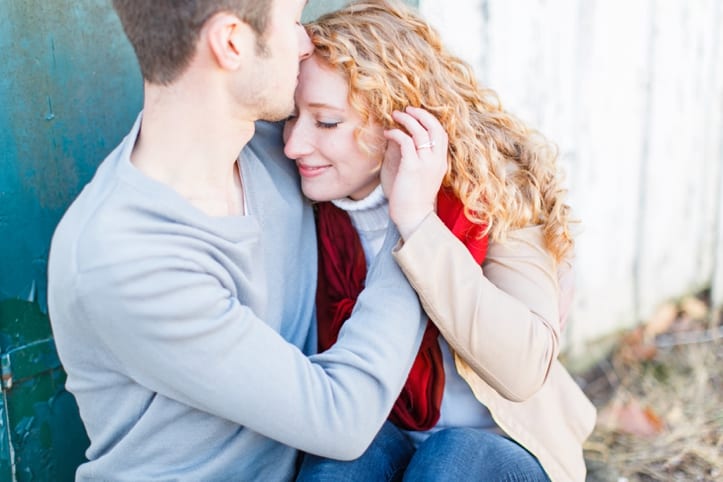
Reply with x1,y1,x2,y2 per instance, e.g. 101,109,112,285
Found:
202,12,256,70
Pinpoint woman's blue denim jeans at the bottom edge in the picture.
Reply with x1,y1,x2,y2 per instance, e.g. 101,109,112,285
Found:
297,422,549,482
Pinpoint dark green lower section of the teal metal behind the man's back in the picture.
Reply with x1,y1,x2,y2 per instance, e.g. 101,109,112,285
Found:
0,300,88,481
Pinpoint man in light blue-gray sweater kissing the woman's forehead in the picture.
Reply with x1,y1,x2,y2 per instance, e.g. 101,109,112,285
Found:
49,0,424,480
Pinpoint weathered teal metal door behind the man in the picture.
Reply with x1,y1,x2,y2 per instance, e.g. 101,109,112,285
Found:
0,0,417,481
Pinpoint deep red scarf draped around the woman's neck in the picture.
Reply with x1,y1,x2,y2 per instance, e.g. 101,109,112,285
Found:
316,190,487,430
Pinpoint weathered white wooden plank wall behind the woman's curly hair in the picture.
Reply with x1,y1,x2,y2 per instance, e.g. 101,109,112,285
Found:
420,0,723,350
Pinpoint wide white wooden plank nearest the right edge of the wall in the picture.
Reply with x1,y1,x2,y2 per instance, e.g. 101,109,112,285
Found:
638,2,720,319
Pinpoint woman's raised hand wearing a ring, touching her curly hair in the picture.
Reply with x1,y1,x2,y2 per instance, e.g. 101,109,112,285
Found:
381,107,447,239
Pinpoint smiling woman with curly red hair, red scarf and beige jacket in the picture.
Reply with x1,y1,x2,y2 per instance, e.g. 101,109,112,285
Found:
284,0,595,480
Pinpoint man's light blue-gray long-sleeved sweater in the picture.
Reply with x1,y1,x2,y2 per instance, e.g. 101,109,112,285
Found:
48,116,424,481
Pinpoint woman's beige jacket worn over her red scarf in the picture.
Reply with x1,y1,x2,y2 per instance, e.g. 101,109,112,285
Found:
395,215,595,481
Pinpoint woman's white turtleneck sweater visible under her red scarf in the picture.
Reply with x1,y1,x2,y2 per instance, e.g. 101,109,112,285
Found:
331,185,497,446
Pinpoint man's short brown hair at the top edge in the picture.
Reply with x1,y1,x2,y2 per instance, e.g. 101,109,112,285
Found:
113,0,273,84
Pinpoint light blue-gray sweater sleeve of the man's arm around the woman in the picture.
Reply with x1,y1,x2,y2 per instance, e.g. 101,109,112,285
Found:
76,224,425,459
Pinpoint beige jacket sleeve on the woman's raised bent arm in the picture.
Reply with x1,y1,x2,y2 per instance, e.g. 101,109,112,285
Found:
395,214,559,401
